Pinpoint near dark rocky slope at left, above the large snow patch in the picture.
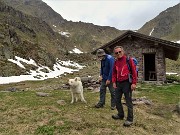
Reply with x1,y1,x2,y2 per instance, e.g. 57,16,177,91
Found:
0,2,72,76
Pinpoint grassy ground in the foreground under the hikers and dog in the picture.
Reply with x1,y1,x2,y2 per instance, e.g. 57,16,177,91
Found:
0,79,180,135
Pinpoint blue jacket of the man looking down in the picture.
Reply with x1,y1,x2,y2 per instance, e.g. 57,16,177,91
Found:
100,54,114,81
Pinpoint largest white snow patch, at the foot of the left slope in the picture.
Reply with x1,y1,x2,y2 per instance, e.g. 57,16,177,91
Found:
0,56,85,84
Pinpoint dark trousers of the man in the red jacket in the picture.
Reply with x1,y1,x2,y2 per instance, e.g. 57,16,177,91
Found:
115,80,133,121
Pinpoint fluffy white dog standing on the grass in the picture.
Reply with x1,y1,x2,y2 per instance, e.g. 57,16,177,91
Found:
69,77,86,104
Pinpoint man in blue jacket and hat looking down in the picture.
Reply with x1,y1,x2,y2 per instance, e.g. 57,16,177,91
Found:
95,49,115,110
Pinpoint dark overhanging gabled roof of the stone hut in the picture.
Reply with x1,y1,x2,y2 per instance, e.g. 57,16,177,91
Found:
92,31,180,60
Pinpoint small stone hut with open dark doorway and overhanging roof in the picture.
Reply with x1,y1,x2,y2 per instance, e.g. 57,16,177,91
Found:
92,31,180,83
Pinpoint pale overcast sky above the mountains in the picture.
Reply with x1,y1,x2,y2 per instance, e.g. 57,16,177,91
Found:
43,0,180,30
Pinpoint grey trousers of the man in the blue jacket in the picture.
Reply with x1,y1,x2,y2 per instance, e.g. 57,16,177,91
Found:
99,80,116,107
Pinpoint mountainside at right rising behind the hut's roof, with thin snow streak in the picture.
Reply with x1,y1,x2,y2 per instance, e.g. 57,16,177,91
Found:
138,4,180,41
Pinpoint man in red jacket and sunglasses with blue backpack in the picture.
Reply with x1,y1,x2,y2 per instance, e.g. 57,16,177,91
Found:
112,46,137,126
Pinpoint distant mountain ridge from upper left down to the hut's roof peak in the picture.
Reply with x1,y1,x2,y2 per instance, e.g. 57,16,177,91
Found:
3,0,123,52
